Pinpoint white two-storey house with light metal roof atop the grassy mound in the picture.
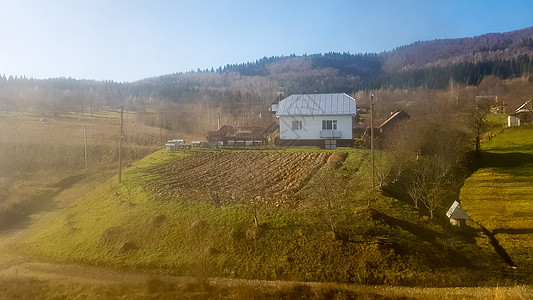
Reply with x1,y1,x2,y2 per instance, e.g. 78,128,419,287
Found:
272,93,356,149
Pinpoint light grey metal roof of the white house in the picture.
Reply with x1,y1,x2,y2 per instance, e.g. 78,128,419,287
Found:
276,93,355,117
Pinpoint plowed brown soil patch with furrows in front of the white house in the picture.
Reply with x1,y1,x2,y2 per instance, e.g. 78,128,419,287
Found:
148,151,330,206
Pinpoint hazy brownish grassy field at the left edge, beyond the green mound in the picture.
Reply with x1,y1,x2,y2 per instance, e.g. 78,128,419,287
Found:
0,110,171,229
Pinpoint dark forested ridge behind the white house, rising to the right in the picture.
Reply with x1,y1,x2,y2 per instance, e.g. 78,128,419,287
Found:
133,27,533,94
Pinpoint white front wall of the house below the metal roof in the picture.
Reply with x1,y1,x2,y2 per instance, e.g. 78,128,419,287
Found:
279,115,352,140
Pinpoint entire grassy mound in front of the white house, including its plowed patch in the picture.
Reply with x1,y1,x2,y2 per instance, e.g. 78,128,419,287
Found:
21,148,527,286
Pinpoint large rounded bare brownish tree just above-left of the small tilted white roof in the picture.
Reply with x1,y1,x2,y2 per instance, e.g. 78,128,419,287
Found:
385,114,468,218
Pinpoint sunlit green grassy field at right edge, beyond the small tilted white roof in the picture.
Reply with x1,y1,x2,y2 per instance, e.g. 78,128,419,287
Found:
460,127,533,276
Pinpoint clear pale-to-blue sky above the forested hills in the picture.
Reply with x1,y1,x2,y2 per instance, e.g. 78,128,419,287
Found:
0,0,533,82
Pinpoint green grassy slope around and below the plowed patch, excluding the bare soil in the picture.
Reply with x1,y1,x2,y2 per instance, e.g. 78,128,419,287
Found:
26,149,503,286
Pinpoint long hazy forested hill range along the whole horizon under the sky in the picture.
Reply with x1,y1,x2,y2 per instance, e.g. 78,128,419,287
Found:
0,27,533,110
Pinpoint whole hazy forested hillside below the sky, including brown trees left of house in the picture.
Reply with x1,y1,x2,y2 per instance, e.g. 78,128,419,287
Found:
0,27,533,134
